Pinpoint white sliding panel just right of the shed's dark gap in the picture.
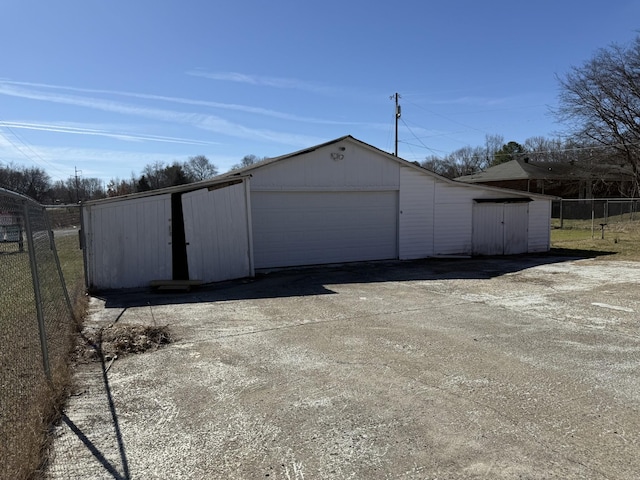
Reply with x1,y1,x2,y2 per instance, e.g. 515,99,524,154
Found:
182,183,252,282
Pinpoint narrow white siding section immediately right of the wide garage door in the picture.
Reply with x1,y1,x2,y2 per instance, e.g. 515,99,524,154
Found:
398,167,435,260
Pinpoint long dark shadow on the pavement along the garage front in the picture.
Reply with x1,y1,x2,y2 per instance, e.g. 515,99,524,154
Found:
94,249,609,309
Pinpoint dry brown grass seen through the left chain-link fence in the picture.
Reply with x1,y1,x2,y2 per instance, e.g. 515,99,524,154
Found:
0,231,87,480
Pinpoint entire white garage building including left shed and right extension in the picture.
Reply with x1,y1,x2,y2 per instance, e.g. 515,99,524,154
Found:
83,136,553,289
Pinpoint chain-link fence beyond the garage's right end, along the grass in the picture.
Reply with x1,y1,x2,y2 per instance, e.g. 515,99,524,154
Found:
551,198,640,230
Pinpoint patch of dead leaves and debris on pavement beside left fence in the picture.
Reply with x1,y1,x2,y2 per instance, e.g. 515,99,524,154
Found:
76,325,173,361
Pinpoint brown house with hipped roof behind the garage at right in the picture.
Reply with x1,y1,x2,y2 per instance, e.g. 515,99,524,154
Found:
456,159,633,198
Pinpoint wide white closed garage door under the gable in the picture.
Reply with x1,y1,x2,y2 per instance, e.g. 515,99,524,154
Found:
251,191,398,268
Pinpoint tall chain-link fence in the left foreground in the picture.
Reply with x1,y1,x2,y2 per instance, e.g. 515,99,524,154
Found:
0,189,75,479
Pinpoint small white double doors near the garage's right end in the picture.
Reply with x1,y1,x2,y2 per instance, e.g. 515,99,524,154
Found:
473,202,529,255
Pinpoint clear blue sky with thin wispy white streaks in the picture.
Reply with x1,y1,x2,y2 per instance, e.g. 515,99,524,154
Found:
0,0,640,181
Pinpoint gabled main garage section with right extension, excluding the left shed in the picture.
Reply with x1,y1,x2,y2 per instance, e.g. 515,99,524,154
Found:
228,136,552,268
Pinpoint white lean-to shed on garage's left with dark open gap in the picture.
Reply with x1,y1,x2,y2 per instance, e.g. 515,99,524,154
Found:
82,176,253,290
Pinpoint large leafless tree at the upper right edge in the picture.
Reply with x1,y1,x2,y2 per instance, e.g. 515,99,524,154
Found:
554,36,640,194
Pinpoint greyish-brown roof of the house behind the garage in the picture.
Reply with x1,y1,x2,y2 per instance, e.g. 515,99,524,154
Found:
456,159,631,183
